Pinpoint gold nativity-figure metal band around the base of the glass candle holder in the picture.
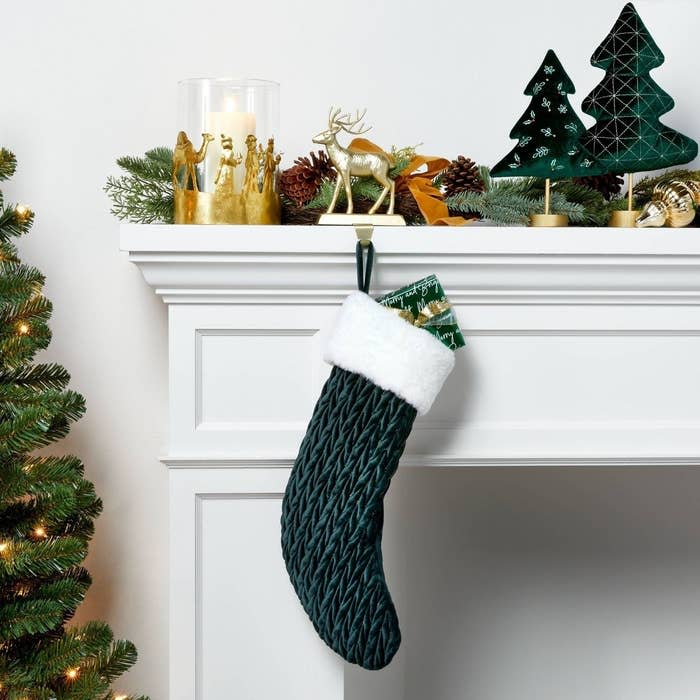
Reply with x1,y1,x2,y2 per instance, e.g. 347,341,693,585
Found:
172,131,282,224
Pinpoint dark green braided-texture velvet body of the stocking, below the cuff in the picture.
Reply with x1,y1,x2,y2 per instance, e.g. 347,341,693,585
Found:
282,367,416,670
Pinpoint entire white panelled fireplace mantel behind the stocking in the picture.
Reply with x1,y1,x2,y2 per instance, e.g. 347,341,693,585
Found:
121,225,700,700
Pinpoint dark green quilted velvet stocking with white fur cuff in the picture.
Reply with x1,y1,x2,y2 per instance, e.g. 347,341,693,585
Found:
282,292,454,669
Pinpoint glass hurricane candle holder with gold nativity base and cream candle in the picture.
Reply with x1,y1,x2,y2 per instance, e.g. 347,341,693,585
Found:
173,78,281,224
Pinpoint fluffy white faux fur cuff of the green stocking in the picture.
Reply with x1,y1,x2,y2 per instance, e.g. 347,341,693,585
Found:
324,292,455,415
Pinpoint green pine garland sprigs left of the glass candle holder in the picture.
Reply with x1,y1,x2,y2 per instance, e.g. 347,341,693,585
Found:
104,146,175,224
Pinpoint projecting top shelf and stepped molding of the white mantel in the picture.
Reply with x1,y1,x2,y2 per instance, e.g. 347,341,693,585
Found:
121,224,700,306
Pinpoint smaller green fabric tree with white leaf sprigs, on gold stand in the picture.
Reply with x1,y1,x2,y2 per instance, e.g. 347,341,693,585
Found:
491,49,597,226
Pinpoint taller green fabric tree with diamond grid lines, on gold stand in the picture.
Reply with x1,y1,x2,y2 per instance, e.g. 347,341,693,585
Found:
581,3,698,226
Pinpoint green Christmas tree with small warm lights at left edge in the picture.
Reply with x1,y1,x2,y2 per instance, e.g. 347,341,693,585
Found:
0,149,148,700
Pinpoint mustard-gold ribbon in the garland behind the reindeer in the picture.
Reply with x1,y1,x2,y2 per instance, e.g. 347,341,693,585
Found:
348,138,473,226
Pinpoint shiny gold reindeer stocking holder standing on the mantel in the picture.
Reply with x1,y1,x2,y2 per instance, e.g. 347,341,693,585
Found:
312,107,405,224
